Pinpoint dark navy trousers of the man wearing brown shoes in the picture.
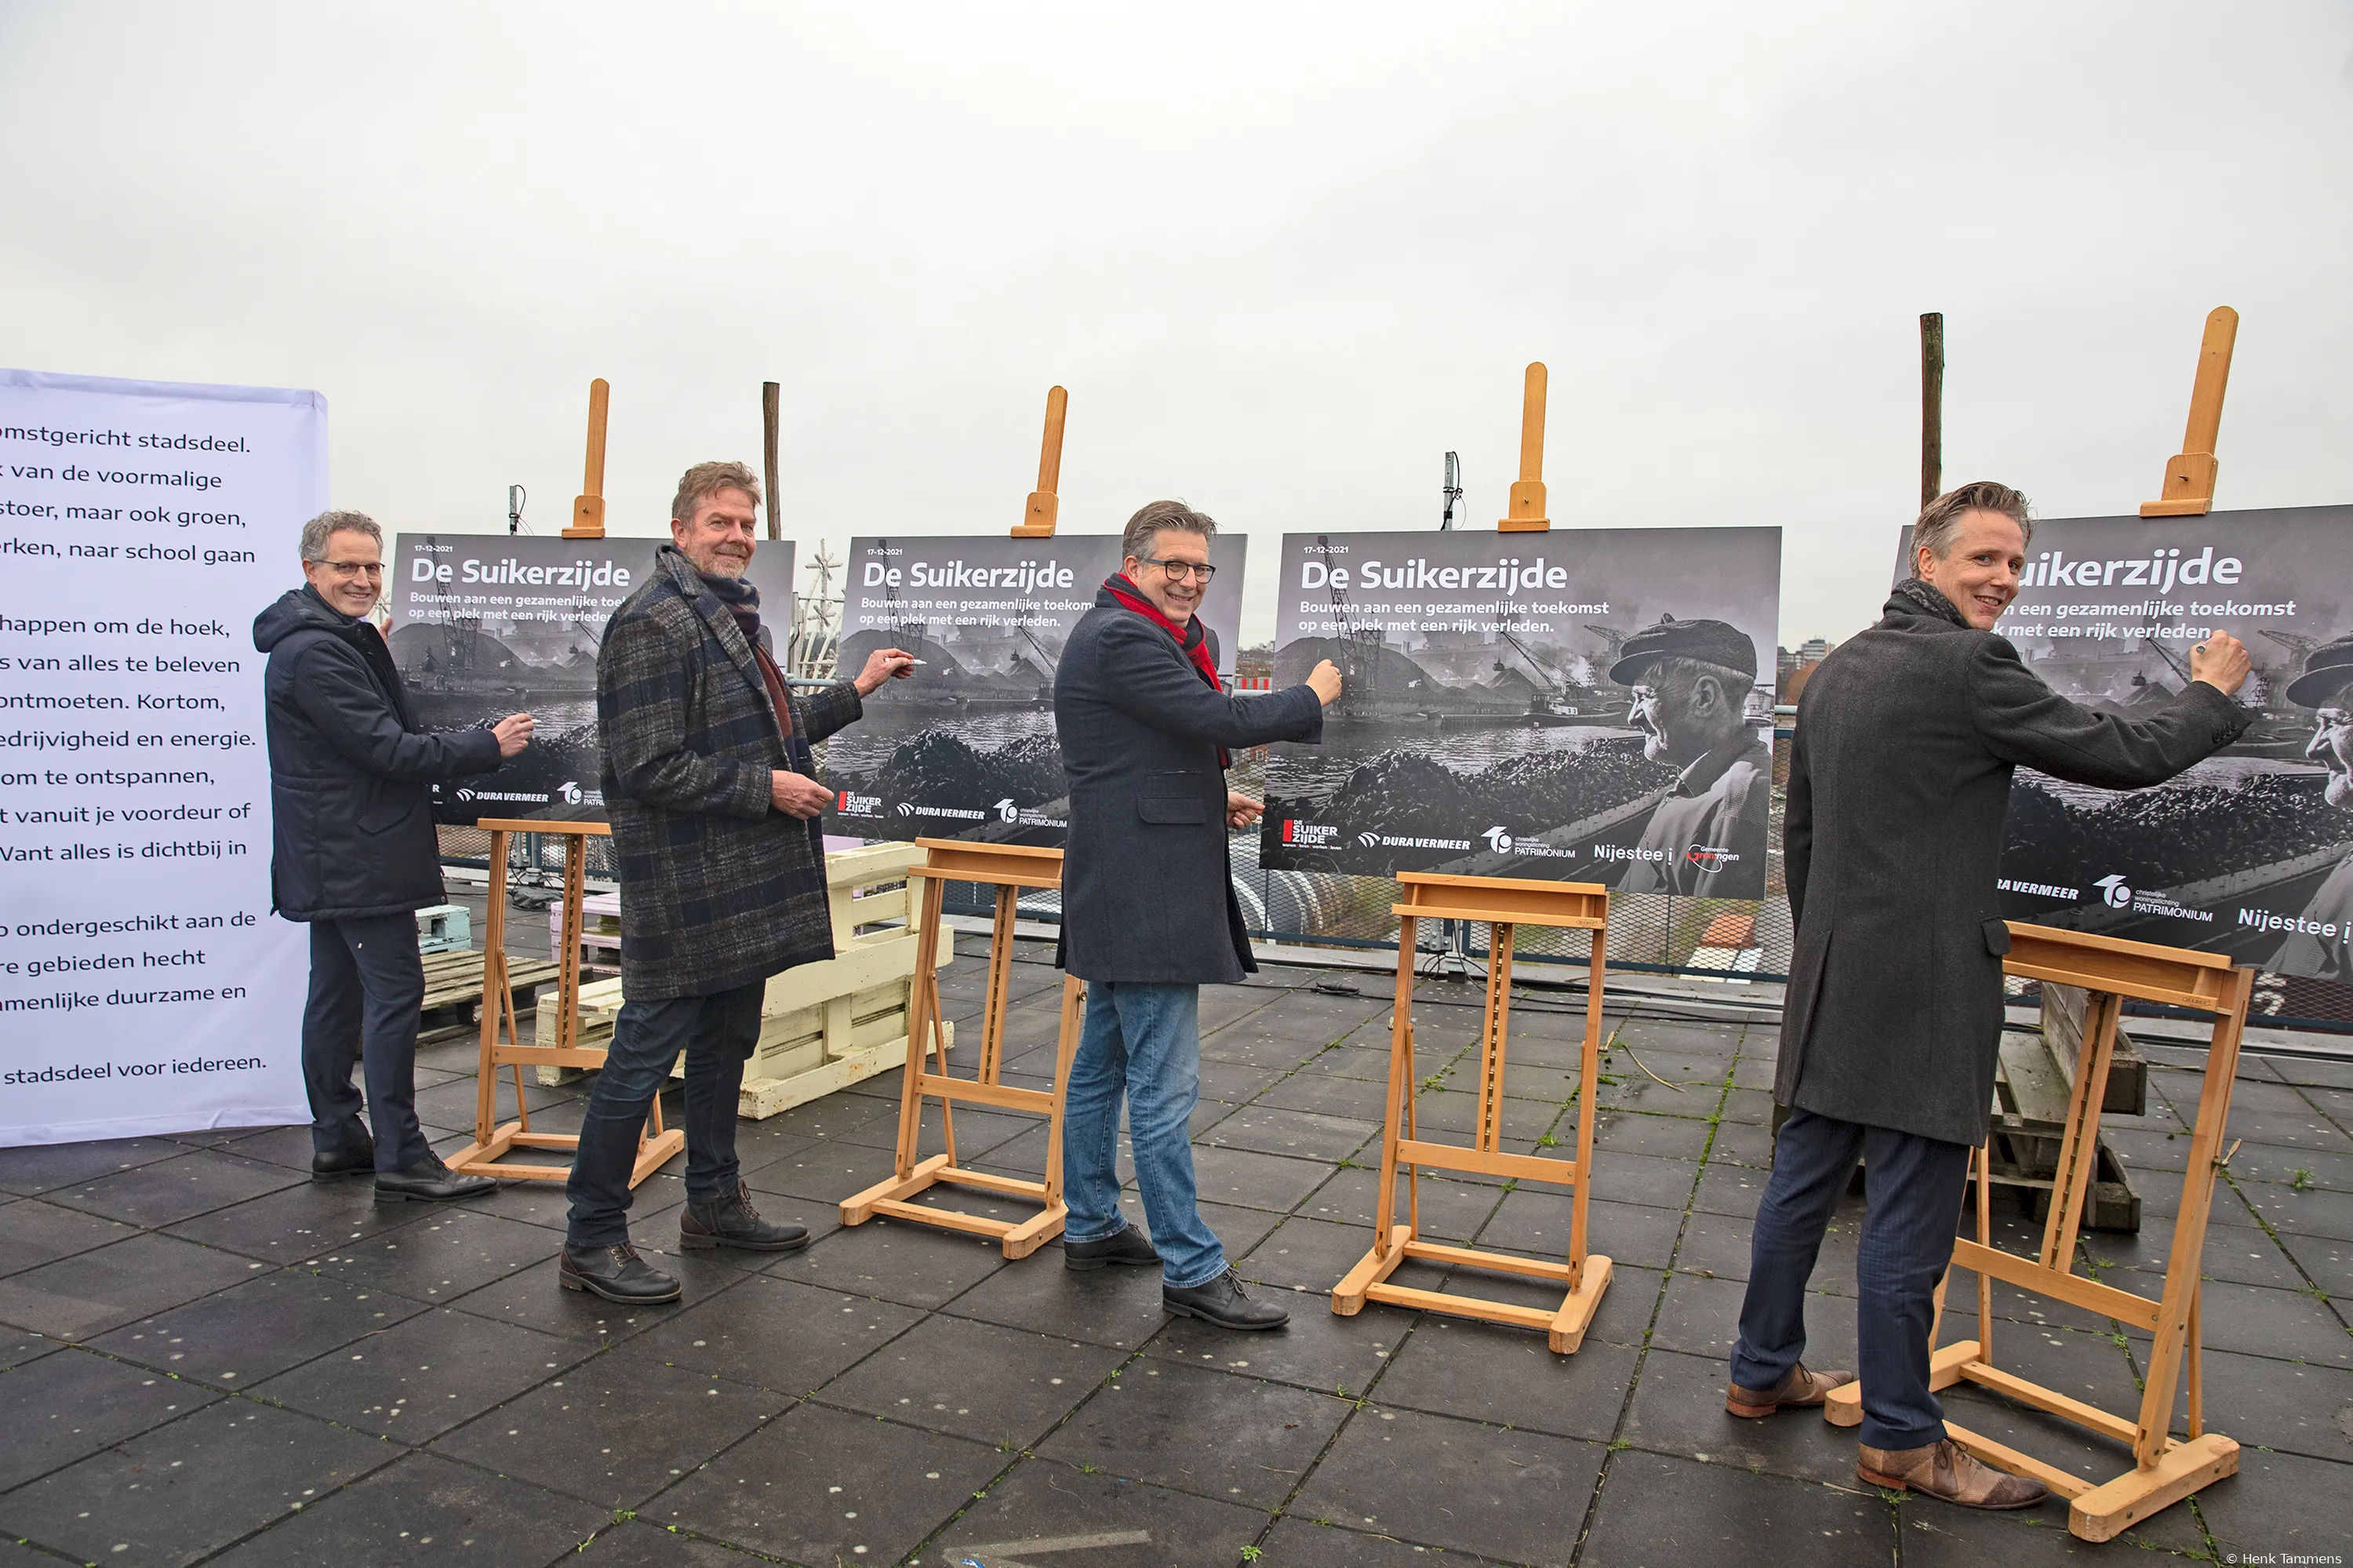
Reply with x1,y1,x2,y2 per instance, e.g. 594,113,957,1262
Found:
1732,1111,1969,1448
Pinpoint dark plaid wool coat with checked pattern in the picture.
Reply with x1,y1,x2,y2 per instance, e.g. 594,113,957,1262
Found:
595,546,864,1001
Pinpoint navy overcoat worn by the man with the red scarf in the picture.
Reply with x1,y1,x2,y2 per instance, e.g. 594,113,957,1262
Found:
1054,591,1322,984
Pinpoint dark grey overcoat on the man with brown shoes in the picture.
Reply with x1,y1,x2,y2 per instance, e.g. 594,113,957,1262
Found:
1774,581,2254,1144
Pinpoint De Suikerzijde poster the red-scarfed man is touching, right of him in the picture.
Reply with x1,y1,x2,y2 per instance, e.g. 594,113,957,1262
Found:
1259,527,1781,900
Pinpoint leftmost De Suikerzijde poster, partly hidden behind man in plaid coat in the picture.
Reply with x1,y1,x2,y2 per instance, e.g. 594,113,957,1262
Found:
384,534,793,824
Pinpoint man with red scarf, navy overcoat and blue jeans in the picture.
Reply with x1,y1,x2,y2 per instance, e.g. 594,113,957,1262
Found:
1054,501,1339,1328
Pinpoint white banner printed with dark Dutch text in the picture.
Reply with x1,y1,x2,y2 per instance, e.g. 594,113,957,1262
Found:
0,369,327,1144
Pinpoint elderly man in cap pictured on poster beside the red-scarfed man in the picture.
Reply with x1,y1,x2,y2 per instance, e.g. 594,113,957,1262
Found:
1609,617,1772,897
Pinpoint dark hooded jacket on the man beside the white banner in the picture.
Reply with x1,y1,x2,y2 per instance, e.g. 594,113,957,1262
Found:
254,584,499,921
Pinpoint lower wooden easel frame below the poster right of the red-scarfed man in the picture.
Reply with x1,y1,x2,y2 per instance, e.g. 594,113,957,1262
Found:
1332,871,1609,1356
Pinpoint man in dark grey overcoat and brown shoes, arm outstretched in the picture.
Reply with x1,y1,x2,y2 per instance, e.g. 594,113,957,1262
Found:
1725,480,2254,1509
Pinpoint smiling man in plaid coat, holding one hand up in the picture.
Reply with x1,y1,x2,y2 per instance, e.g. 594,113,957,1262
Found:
558,464,915,1304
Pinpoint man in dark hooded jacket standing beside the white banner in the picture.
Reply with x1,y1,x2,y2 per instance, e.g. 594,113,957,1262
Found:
254,511,532,1203
